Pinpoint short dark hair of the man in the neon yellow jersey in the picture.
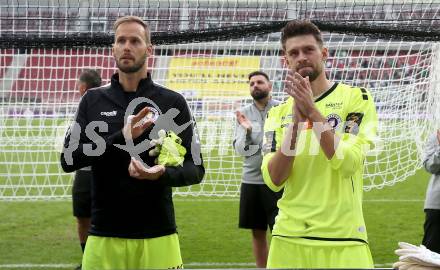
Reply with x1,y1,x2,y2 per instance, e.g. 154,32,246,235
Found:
281,20,324,50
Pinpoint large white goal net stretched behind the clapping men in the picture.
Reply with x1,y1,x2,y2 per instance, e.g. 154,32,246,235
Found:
0,0,440,200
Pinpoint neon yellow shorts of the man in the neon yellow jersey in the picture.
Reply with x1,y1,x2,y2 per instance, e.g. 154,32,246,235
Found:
267,236,374,269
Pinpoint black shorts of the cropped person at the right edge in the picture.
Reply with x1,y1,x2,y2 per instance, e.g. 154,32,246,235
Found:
422,209,440,253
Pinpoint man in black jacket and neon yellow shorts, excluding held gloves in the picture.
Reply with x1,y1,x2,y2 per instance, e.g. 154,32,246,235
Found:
61,16,205,270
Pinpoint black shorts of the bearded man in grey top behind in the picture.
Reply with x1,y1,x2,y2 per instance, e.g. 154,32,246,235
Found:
238,183,283,230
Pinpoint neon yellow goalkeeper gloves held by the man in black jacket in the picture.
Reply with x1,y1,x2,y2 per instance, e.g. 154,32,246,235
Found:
149,130,186,166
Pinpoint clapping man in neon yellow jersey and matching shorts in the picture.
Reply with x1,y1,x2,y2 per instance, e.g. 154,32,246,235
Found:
261,21,377,269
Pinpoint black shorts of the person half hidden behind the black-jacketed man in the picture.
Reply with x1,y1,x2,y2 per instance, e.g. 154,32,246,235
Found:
72,170,92,218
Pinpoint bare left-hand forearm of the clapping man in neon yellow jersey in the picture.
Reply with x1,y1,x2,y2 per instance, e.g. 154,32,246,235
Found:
268,124,298,186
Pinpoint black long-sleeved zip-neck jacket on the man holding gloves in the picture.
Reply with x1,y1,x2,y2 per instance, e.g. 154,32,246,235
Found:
61,74,205,238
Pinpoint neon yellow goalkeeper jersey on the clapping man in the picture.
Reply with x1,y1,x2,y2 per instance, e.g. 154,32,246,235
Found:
261,83,377,244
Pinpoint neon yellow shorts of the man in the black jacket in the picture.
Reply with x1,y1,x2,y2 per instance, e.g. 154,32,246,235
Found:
82,233,183,270
